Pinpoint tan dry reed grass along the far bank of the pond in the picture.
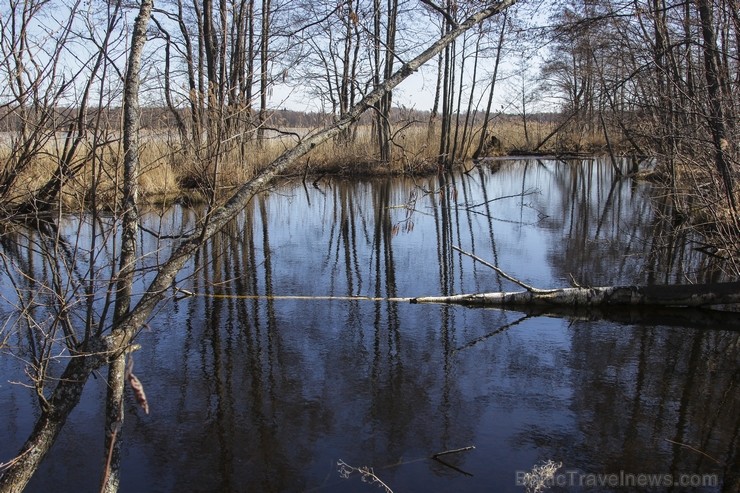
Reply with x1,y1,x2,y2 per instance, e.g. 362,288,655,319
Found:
0,119,612,209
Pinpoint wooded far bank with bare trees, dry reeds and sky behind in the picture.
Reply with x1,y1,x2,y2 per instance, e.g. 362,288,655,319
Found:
0,0,740,208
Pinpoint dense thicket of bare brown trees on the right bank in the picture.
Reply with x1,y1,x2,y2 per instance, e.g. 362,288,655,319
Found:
543,0,740,229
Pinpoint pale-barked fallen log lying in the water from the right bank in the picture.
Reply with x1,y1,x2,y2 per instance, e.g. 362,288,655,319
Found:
410,281,740,308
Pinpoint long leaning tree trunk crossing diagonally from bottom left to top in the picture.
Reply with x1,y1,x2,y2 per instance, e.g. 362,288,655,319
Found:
0,0,516,493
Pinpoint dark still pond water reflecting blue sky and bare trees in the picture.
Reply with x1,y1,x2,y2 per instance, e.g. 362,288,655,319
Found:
0,160,740,493
